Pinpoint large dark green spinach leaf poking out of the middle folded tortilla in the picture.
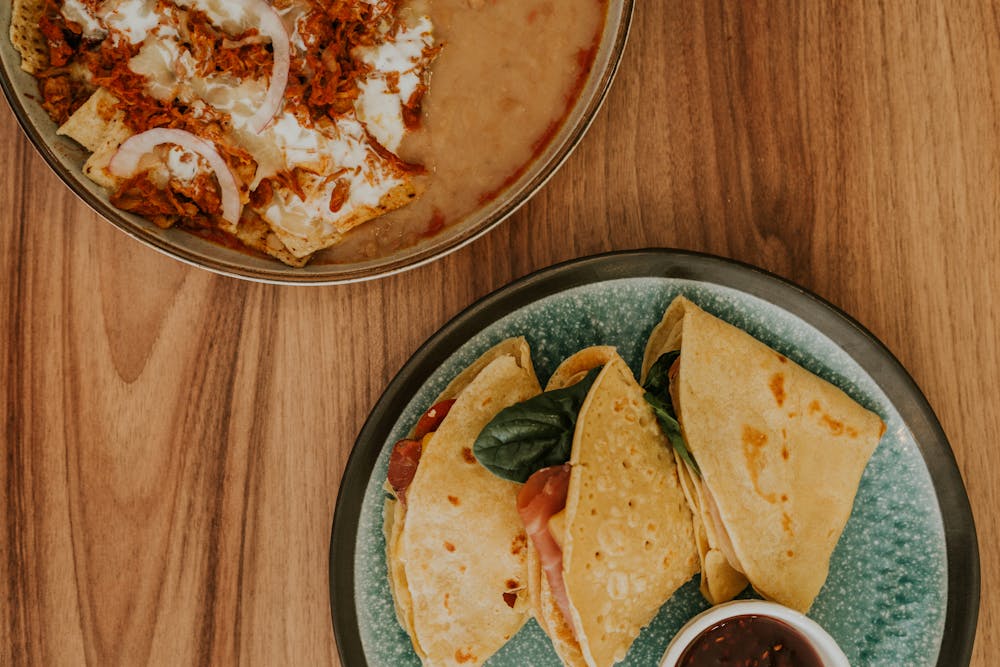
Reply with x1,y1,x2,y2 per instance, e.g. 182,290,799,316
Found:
472,366,602,483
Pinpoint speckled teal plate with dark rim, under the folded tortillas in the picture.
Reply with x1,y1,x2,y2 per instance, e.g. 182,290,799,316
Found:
330,250,979,667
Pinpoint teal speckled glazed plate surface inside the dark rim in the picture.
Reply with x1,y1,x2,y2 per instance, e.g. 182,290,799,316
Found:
355,278,947,667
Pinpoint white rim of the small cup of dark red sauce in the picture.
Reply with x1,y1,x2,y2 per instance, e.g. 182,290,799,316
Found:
660,600,851,667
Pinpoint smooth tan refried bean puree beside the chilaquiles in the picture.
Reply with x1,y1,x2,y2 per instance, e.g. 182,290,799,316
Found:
313,0,608,264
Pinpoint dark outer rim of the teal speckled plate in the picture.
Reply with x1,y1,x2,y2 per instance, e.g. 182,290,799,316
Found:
329,248,981,667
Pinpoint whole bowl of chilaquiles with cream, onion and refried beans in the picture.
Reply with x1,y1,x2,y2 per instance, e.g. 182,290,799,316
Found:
0,0,632,283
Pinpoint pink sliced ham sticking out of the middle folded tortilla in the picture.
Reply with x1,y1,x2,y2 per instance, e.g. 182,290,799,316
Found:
517,463,576,635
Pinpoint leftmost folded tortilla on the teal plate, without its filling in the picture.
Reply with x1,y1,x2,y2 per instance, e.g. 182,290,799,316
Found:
385,338,541,666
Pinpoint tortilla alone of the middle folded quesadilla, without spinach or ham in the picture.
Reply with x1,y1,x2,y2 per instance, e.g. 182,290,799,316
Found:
529,347,698,667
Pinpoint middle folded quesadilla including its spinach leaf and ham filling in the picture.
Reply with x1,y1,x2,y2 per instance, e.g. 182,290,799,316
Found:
476,347,698,667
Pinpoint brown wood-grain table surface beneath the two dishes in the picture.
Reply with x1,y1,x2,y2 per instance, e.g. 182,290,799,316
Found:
0,0,1000,666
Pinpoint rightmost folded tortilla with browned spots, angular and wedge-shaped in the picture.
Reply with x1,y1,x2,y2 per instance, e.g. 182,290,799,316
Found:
643,297,885,611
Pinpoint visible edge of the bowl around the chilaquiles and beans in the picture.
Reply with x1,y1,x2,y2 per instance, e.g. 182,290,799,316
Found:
0,0,634,285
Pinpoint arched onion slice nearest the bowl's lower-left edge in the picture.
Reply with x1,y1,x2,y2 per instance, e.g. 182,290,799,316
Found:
108,127,243,224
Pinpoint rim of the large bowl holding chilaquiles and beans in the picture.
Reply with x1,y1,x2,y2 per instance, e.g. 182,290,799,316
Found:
0,0,635,286
